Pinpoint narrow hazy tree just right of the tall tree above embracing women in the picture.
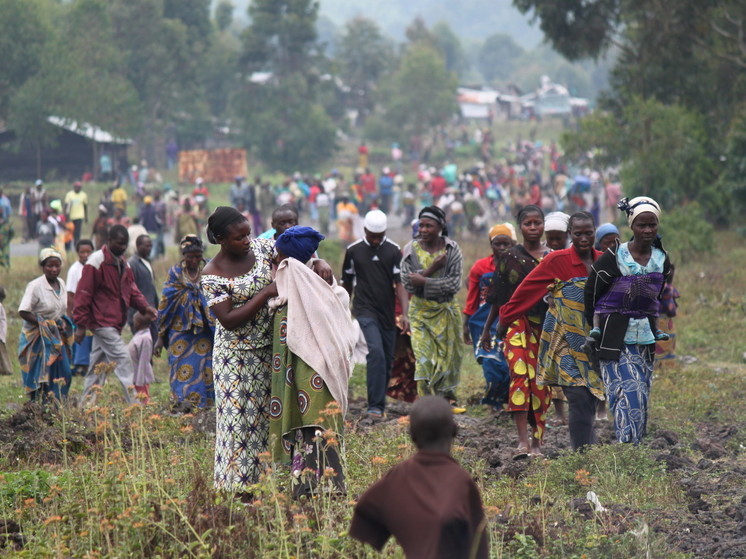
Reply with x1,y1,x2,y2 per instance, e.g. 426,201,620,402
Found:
337,18,394,124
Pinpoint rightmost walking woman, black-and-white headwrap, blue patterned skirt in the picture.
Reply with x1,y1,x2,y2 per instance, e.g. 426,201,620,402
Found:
585,196,671,444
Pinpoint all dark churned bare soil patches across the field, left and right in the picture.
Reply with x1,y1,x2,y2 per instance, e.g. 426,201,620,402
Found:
0,399,746,559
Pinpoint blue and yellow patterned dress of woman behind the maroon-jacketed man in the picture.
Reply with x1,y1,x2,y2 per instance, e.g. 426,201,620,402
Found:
158,265,215,408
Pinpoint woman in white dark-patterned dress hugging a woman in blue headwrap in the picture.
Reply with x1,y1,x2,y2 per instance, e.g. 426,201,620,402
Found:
202,206,331,499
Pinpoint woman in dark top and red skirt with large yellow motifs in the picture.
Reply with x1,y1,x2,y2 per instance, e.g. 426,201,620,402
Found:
481,205,552,459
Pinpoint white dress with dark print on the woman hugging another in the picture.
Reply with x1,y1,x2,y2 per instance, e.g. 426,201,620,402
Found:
202,239,274,492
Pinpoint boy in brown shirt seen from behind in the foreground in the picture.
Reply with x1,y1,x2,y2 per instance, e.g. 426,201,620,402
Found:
350,396,488,559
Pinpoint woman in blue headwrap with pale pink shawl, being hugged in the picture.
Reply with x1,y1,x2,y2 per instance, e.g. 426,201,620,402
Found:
269,226,358,498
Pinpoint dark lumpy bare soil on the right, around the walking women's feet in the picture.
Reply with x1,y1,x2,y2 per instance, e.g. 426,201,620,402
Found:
348,399,746,559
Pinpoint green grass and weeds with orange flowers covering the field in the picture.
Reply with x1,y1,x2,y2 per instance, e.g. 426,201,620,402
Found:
0,212,746,559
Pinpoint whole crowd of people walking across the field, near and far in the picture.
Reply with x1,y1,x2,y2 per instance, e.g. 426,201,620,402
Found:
0,150,678,556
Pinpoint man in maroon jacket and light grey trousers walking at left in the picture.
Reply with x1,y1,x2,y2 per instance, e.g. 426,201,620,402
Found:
73,225,158,404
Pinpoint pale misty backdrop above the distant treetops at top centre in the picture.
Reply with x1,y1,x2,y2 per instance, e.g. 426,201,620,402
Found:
225,0,543,49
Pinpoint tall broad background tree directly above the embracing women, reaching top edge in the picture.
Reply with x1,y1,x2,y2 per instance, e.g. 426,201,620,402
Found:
235,0,336,172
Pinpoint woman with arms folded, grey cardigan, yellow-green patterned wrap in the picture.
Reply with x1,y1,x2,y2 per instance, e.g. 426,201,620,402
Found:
401,206,466,413
